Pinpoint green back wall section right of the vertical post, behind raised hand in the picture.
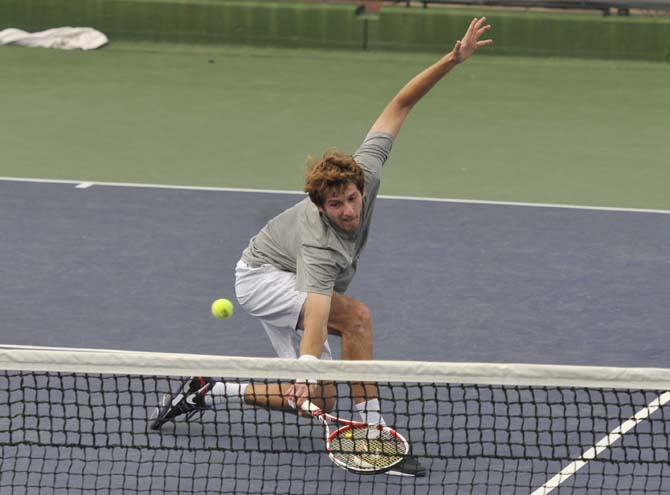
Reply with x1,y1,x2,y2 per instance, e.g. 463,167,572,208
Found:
370,9,670,61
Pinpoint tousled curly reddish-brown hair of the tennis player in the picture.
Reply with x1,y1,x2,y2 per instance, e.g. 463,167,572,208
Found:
305,148,365,207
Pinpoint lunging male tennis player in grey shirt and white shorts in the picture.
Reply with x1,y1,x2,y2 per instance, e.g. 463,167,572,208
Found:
152,17,493,476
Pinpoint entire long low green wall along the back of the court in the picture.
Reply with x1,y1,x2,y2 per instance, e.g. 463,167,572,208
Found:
0,0,670,61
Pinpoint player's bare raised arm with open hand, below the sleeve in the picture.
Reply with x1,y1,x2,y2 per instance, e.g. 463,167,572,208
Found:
370,17,493,136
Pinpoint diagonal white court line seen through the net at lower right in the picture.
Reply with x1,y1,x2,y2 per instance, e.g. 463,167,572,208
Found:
531,392,670,495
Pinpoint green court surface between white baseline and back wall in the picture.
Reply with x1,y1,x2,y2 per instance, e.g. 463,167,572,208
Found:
0,42,670,210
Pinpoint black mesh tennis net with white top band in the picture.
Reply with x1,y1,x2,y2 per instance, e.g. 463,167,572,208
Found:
0,347,670,495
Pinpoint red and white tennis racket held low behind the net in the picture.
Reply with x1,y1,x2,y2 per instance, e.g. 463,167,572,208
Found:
302,400,410,474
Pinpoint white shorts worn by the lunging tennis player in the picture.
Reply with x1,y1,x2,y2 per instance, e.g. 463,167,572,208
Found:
235,260,332,359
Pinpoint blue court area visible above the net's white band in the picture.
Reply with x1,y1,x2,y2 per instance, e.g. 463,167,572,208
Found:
0,181,670,367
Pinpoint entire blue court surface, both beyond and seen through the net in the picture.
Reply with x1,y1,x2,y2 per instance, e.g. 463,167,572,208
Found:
0,180,670,494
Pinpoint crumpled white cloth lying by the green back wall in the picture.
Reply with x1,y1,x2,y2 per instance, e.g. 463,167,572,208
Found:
0,27,109,50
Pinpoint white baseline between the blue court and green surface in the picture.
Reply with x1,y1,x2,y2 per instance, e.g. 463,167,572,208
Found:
0,177,670,215
